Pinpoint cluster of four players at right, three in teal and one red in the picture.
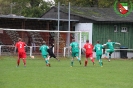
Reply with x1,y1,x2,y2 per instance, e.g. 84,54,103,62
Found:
70,39,121,67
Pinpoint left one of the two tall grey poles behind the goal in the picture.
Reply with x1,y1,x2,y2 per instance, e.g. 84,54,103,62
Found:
57,2,60,57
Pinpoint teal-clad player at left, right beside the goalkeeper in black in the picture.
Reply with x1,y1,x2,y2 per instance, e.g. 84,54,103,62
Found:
39,41,50,67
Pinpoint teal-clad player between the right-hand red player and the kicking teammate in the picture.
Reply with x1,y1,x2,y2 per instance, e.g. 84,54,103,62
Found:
94,40,104,67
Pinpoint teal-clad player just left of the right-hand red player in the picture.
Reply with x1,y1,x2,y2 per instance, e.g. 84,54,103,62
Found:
70,39,81,67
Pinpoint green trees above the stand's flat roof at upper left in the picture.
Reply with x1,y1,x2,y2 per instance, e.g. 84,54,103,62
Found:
0,0,53,17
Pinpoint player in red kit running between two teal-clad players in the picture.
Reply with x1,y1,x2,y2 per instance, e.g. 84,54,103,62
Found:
83,40,95,66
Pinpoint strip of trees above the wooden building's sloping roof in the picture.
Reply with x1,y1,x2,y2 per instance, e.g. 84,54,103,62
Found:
54,0,133,8
